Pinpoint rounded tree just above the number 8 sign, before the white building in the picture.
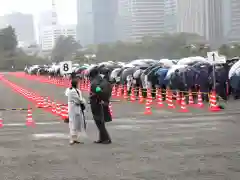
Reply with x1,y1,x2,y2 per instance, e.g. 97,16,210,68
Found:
52,36,82,62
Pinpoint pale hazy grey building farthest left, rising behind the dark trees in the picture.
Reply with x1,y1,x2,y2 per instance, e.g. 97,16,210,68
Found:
4,13,35,43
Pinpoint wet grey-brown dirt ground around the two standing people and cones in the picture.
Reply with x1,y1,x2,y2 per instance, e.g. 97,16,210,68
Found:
0,75,240,180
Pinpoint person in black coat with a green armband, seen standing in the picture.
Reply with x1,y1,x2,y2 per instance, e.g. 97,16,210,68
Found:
89,69,112,144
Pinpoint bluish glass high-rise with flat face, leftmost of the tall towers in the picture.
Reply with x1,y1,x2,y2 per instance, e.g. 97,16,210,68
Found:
77,0,117,46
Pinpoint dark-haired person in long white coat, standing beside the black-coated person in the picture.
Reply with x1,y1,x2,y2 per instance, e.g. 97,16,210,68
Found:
65,80,86,145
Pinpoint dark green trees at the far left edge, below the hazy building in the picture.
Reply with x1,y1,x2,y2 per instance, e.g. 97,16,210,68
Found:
0,26,47,71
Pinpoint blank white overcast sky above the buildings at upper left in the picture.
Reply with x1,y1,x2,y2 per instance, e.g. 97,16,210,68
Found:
0,0,77,24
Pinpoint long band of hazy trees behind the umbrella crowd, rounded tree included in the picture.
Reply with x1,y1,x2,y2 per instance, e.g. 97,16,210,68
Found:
53,33,240,62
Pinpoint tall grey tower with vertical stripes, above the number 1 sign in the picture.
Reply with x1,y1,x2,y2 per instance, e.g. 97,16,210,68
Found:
177,0,223,45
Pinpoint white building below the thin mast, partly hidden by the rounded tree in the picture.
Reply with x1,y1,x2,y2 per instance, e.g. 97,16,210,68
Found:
40,25,76,51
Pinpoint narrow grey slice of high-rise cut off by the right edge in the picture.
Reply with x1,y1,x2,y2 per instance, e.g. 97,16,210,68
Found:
228,0,240,42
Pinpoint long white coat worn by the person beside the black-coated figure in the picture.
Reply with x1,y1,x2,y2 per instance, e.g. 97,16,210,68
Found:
65,88,85,137
